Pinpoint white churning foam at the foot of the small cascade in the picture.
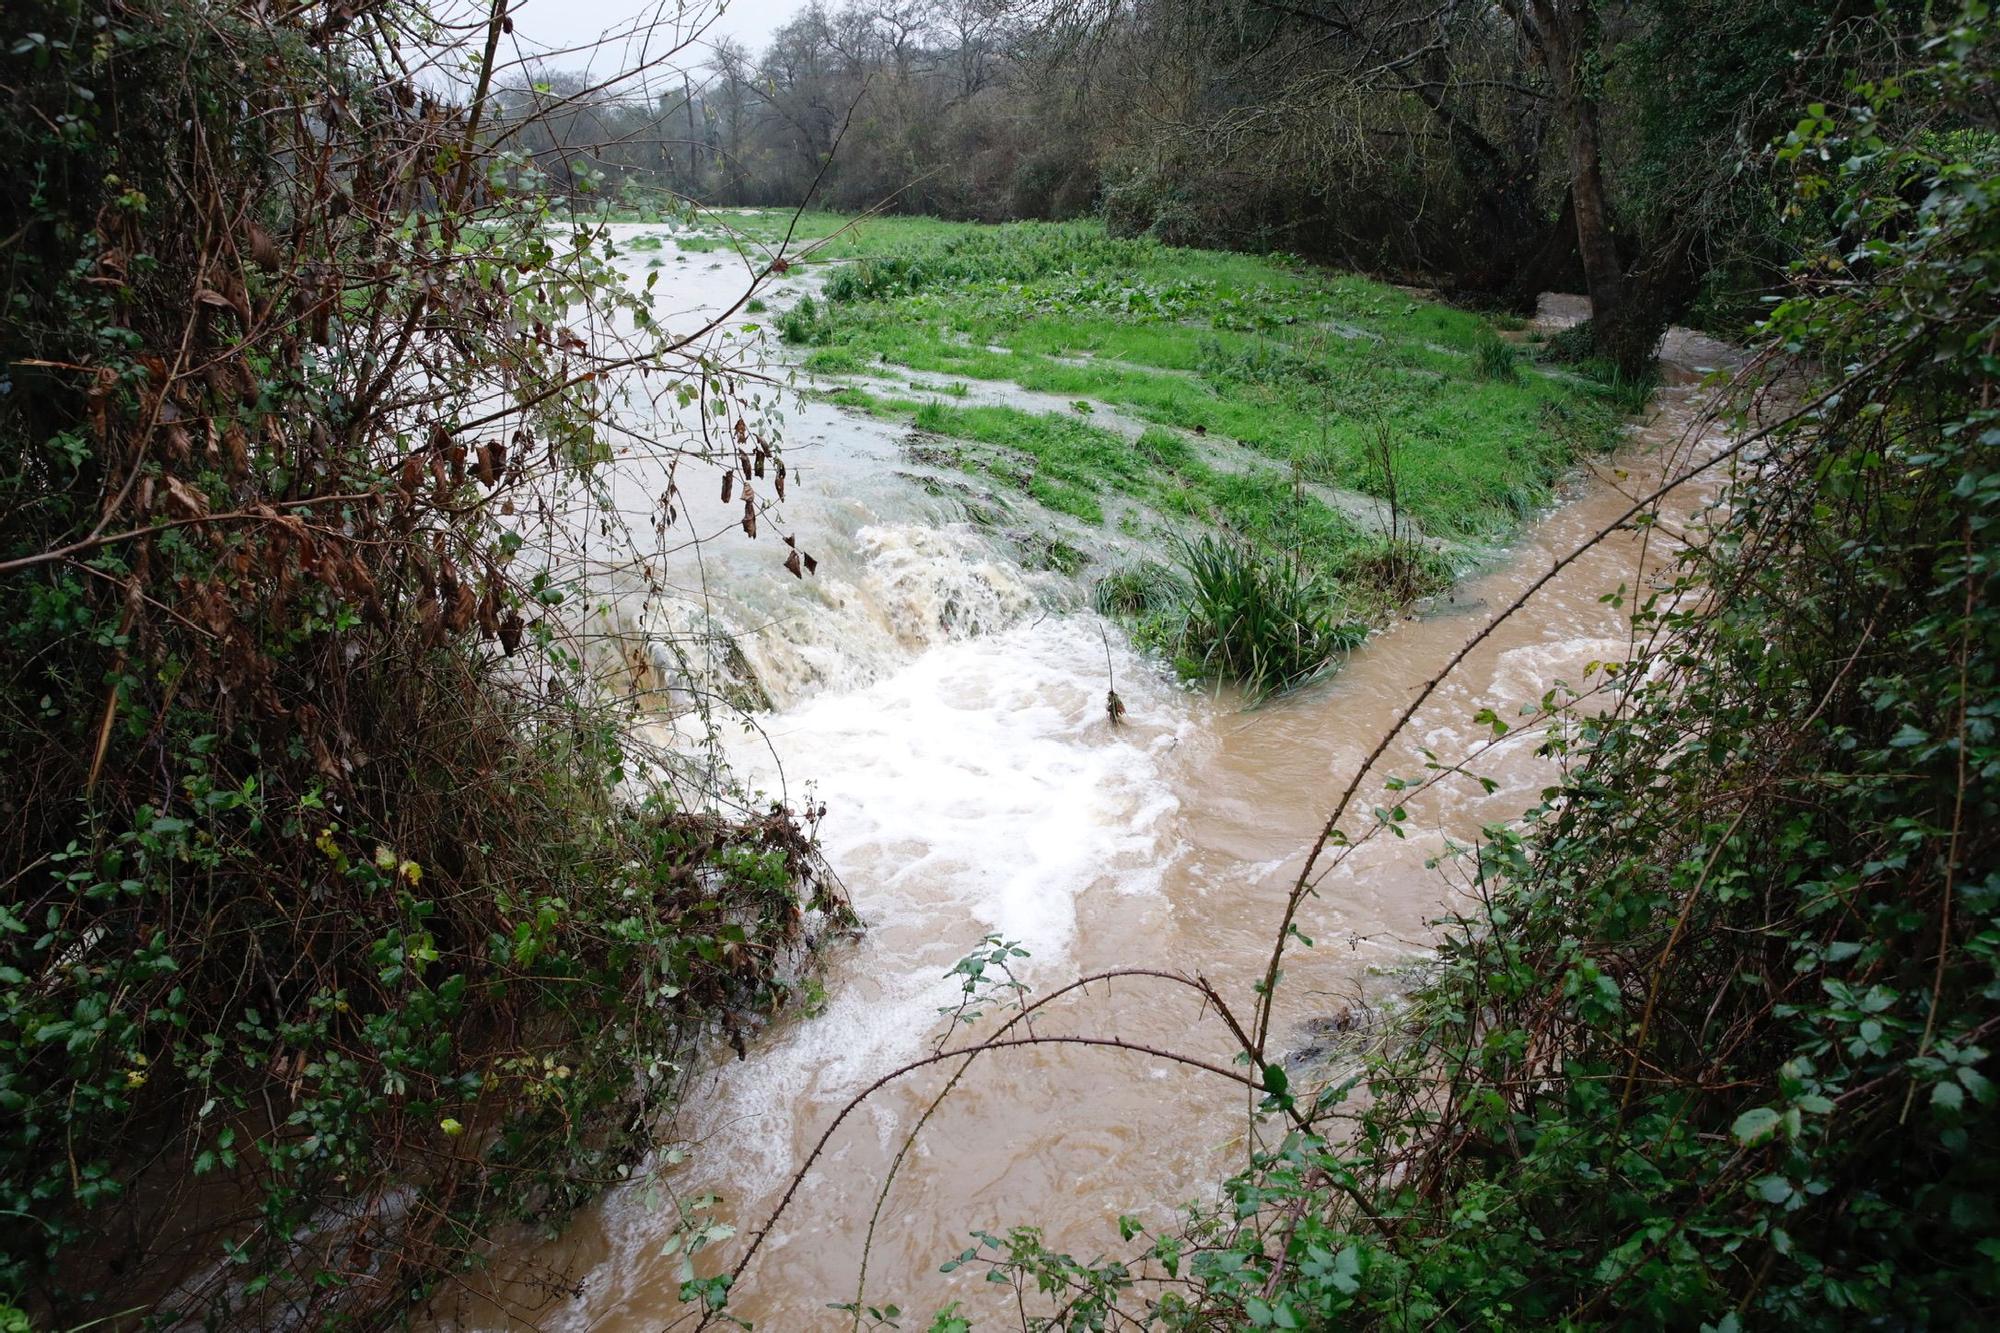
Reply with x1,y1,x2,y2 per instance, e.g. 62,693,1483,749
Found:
706,616,1194,1189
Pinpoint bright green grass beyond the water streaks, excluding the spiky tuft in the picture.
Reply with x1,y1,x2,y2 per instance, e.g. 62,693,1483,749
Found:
738,214,1630,538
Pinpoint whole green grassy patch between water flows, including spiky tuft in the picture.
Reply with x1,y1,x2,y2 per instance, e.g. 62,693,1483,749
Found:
704,212,1650,691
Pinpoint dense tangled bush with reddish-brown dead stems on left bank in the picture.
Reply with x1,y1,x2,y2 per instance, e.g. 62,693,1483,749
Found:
0,0,842,1327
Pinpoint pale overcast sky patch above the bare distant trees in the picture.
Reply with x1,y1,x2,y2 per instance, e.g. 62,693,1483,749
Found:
508,0,808,70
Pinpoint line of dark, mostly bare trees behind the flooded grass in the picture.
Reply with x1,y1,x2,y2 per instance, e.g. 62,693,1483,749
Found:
502,0,1922,370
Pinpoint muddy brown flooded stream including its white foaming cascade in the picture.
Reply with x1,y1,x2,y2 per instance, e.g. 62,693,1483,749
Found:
432,233,1728,1333
